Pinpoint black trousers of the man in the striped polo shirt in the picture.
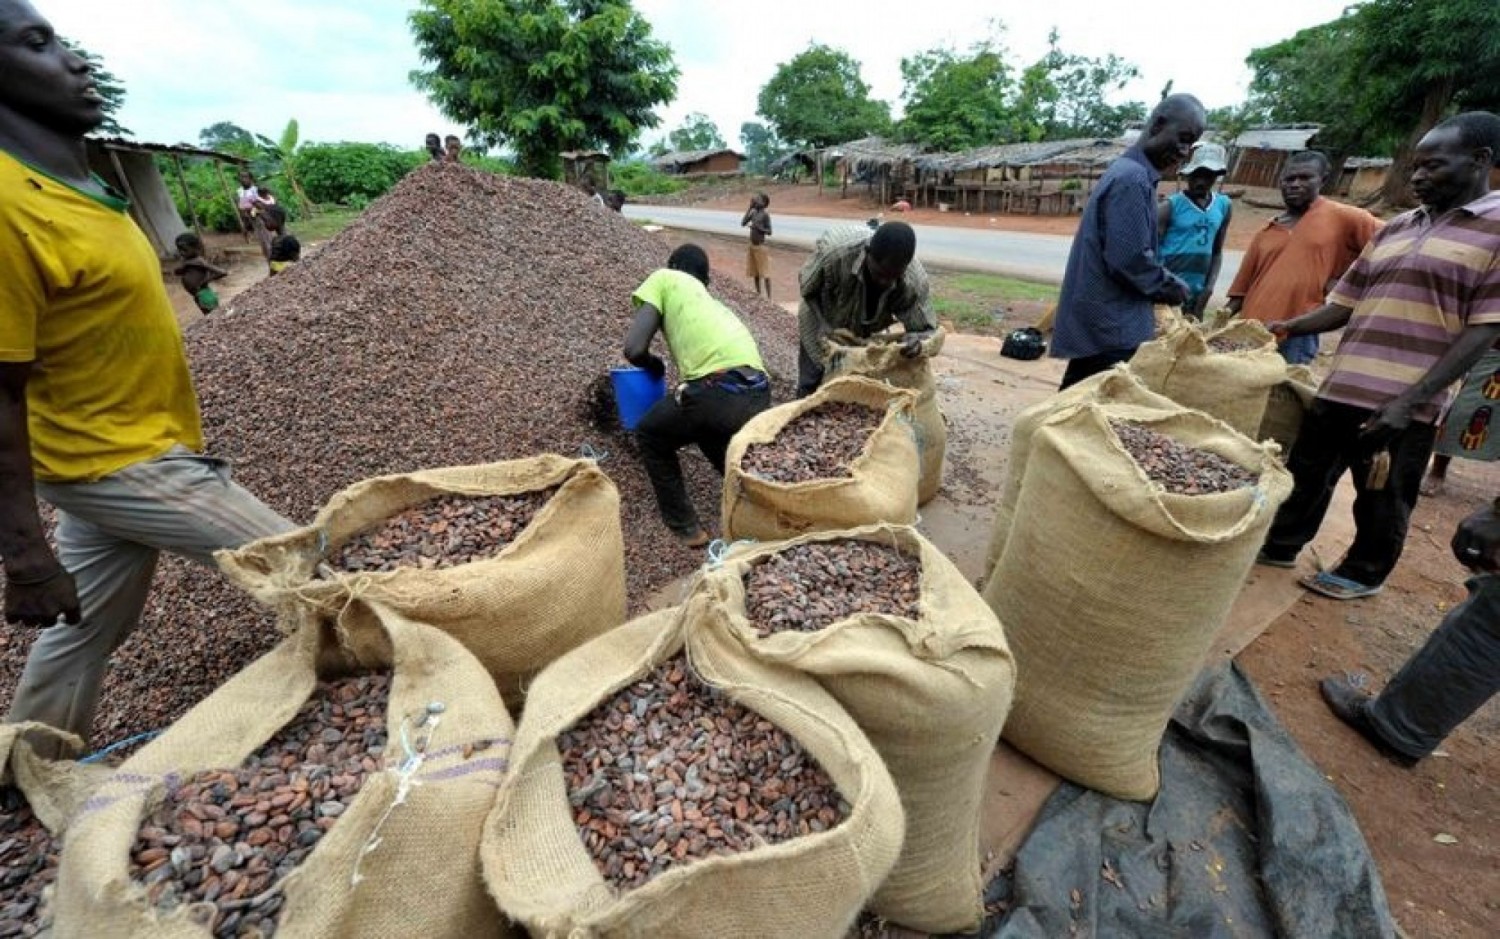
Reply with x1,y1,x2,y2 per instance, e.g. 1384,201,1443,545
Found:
1265,398,1437,587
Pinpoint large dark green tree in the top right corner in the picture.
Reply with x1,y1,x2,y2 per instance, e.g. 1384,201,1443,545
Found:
1247,0,1500,206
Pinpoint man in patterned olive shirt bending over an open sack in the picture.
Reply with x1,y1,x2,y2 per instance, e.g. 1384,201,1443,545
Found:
797,222,938,398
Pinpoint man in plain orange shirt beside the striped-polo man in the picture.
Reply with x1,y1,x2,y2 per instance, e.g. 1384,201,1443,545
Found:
1229,150,1380,365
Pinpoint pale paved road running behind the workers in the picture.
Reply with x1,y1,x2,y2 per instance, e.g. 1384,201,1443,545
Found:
626,206,1242,293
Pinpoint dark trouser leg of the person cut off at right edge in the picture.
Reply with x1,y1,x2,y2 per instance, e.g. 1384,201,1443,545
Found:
1370,575,1500,759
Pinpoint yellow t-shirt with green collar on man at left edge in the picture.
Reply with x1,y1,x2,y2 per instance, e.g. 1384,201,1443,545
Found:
0,152,203,483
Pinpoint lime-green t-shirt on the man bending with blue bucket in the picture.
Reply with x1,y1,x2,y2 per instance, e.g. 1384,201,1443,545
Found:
632,269,765,381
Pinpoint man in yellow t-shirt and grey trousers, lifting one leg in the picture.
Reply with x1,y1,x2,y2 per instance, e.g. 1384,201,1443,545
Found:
0,0,291,740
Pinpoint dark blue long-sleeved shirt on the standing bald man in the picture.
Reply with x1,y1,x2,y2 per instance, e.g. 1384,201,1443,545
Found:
1052,147,1187,359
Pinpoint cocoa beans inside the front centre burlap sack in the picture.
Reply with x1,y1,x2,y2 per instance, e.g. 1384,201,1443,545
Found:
558,656,849,891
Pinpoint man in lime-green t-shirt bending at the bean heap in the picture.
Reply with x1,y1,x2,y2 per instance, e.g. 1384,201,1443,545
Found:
626,245,771,548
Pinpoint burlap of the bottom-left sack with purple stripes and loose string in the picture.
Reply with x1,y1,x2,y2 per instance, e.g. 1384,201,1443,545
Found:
56,611,513,939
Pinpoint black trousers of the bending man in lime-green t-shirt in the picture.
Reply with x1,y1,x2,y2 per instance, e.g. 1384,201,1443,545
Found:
636,381,771,536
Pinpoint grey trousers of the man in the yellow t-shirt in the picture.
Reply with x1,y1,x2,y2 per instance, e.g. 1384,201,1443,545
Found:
6,447,293,741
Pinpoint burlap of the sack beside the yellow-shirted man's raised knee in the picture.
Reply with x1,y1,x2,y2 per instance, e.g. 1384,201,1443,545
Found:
218,455,626,707
